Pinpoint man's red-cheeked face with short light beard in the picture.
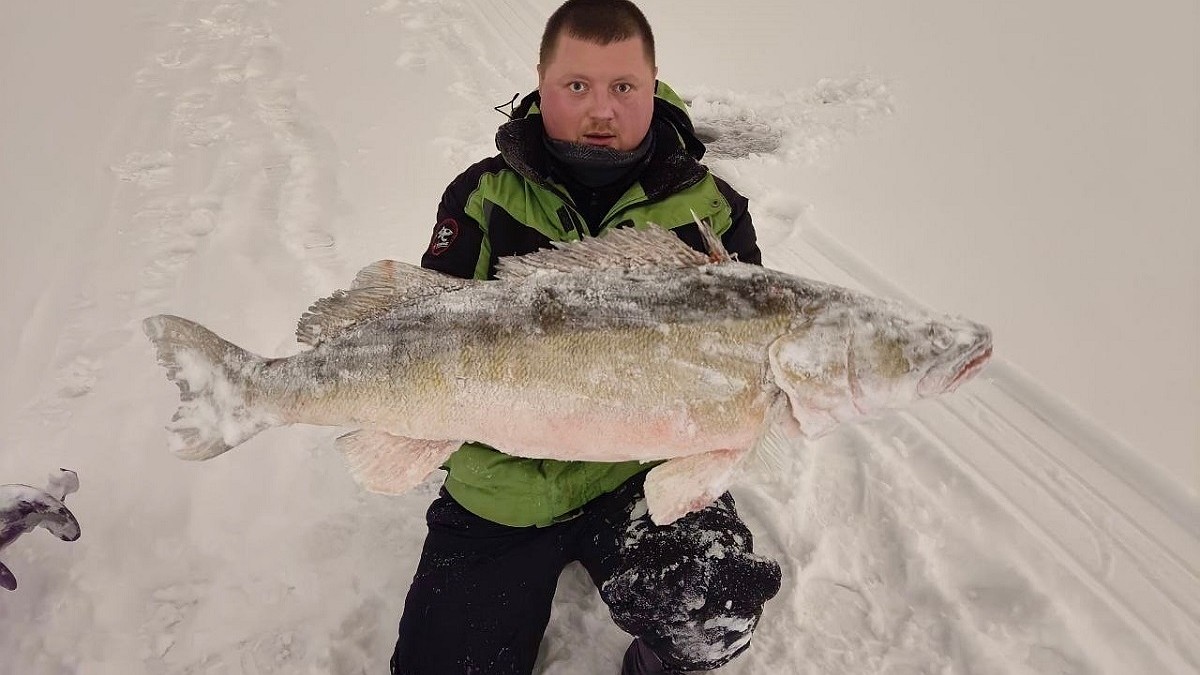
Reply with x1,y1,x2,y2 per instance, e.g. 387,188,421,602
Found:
538,32,658,150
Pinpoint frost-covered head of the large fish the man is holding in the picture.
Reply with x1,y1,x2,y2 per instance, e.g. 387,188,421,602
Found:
769,299,991,438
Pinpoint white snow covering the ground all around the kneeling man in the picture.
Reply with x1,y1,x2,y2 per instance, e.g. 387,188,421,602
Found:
0,0,1200,674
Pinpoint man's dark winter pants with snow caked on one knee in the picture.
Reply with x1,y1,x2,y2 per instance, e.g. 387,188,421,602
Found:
391,476,780,675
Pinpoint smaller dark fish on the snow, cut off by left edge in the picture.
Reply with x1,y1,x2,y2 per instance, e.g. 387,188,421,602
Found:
0,468,80,591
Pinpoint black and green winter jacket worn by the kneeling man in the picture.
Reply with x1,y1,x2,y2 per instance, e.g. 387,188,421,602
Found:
421,82,761,526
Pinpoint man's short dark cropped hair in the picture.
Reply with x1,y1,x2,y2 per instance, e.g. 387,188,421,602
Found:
538,0,654,66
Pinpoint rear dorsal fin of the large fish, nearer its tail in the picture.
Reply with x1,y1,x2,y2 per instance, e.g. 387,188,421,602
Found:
296,261,473,347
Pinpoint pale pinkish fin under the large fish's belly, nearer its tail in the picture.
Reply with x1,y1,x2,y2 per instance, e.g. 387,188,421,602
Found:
336,429,462,495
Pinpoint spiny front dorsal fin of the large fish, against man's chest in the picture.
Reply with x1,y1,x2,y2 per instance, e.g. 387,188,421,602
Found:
496,226,724,279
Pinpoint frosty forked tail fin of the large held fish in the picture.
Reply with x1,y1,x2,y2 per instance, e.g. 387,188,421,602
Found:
142,315,280,460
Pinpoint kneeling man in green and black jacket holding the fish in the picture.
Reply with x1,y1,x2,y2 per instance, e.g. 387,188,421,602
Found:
391,0,780,675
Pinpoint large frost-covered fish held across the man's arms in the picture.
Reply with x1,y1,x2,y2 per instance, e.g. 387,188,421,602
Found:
144,227,991,524
